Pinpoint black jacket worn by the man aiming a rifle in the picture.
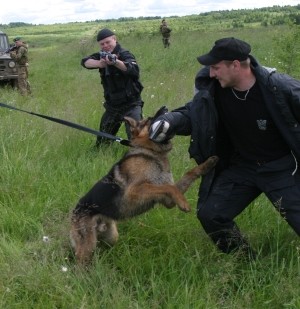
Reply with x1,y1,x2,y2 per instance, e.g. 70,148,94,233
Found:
81,43,143,106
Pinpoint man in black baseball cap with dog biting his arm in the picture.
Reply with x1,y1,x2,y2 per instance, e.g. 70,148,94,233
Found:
150,38,300,258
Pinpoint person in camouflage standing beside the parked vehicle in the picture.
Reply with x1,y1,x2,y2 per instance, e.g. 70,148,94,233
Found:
10,37,31,96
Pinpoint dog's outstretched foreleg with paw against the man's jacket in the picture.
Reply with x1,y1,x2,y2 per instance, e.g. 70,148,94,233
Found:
176,156,219,193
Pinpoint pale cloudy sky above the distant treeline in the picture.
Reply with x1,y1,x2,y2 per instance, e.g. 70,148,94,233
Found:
0,0,300,24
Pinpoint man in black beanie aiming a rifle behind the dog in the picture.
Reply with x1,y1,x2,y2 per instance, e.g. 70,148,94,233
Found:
81,28,144,148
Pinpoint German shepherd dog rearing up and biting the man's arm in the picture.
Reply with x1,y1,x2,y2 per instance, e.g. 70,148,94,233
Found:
70,109,218,265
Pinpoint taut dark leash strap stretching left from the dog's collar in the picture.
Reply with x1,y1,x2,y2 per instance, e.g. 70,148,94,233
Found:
0,103,130,146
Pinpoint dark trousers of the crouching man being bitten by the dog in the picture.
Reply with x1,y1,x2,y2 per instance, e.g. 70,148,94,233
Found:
197,154,300,253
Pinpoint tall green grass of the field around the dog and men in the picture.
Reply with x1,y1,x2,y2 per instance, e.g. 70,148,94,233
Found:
0,20,300,309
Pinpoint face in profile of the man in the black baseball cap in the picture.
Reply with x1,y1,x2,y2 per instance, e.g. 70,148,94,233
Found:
209,61,237,88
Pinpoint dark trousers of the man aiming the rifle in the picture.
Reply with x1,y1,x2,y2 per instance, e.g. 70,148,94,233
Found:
96,104,143,145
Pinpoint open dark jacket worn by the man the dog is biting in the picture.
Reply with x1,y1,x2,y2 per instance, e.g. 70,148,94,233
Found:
163,56,300,198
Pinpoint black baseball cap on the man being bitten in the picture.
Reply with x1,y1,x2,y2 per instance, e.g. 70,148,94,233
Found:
197,38,251,65
